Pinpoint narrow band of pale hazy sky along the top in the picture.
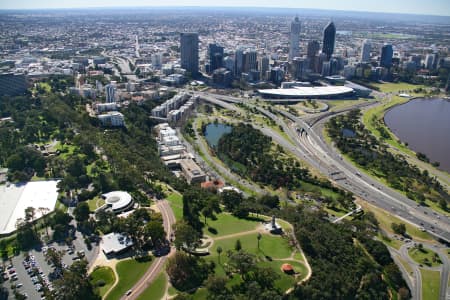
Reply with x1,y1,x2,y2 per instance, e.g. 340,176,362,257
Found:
0,0,450,17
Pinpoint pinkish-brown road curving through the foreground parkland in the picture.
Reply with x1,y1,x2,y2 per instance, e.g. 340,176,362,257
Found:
125,200,176,300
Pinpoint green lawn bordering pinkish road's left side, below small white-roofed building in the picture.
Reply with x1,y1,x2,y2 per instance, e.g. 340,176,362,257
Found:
106,259,152,300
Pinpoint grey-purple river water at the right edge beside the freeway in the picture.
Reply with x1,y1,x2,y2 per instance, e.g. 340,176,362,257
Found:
384,99,450,172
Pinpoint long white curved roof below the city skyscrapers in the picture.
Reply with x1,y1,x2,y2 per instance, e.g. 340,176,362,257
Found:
258,86,354,98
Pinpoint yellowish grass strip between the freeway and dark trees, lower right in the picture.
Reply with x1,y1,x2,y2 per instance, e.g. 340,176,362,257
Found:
357,201,435,243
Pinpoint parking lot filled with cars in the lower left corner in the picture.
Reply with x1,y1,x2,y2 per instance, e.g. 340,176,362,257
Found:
4,227,98,300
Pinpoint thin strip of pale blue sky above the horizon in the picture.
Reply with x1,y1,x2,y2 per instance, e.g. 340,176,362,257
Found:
0,0,450,16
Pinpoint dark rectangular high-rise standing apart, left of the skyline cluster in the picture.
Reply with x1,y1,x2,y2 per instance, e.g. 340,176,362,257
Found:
180,33,198,76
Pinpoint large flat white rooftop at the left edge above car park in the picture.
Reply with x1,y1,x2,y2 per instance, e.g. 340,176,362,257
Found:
0,180,58,234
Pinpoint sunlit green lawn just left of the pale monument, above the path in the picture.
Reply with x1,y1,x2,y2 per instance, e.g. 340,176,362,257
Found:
201,213,262,238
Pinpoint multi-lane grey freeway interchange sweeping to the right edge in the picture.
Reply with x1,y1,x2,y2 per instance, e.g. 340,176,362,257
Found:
196,92,450,243
